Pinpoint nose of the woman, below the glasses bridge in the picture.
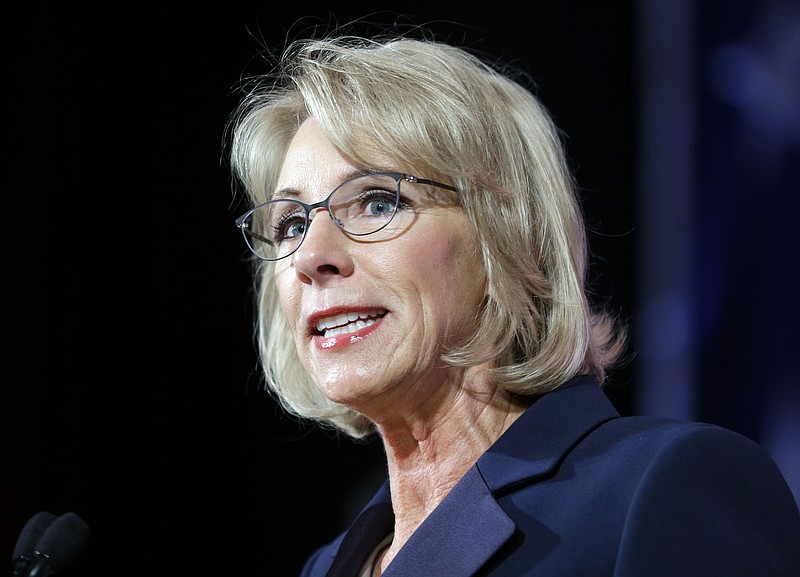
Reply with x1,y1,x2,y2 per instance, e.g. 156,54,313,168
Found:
289,208,353,284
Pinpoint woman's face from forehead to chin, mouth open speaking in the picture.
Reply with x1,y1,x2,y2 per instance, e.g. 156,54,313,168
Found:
275,118,485,419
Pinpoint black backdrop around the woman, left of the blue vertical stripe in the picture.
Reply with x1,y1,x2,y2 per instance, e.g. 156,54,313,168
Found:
7,0,792,577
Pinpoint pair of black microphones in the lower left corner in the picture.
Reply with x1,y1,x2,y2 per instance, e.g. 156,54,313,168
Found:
13,512,89,577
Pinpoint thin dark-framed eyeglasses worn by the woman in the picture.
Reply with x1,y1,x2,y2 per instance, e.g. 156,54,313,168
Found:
236,172,458,261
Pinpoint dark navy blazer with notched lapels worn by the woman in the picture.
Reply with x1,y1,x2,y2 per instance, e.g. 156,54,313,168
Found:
302,377,800,577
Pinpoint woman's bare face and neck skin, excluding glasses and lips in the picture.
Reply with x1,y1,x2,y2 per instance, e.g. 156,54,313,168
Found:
274,119,526,570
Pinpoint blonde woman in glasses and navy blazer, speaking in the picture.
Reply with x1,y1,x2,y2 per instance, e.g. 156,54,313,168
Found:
231,38,800,577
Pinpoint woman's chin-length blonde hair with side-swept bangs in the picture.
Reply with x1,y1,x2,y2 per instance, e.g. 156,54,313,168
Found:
225,36,625,438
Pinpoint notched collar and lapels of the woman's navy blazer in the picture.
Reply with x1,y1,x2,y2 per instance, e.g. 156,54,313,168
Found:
326,377,619,577
